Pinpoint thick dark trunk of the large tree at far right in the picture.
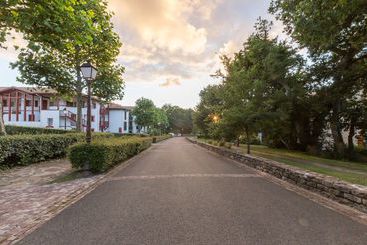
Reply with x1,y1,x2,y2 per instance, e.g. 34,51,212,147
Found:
330,100,346,157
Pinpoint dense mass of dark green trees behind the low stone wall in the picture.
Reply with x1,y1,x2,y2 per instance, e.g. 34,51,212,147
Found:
195,5,367,157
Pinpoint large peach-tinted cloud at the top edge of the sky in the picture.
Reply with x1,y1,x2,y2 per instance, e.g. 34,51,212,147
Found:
109,0,210,55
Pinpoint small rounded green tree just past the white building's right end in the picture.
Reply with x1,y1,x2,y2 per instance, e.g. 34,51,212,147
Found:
132,97,156,130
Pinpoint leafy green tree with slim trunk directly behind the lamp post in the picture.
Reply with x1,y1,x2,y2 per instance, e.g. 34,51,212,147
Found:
12,0,124,130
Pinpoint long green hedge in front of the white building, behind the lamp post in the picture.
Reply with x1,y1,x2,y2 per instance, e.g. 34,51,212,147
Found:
0,133,113,168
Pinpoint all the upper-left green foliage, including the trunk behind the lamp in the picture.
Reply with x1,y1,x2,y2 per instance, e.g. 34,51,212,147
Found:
5,0,124,130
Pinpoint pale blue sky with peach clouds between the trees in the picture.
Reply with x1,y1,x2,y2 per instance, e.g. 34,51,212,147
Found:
0,0,282,108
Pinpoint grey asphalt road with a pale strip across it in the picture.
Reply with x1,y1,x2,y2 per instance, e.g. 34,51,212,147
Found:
20,138,367,245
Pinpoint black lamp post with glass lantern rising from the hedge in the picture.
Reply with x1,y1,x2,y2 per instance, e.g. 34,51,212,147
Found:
80,61,97,144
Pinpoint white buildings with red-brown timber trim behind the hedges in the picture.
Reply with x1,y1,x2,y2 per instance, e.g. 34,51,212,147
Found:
0,87,139,133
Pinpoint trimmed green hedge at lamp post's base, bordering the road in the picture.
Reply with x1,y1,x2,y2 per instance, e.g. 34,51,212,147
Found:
68,137,152,172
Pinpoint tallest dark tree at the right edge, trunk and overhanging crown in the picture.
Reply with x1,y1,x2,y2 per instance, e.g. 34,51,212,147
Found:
270,0,367,156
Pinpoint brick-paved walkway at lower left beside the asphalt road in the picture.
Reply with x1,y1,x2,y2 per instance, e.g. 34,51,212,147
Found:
0,159,102,244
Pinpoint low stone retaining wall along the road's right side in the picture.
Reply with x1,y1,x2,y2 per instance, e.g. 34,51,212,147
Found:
187,138,367,213
